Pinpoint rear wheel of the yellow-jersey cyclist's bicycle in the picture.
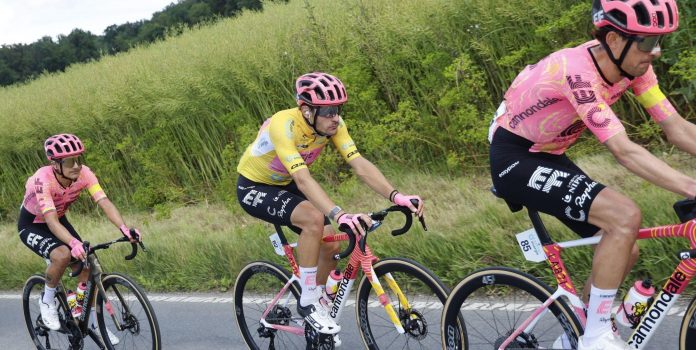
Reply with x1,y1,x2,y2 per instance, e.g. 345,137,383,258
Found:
234,261,306,350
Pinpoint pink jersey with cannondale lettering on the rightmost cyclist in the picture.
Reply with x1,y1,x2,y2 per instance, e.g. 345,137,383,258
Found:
489,40,676,154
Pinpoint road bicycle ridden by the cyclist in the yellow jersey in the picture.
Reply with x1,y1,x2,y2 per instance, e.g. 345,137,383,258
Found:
234,202,463,350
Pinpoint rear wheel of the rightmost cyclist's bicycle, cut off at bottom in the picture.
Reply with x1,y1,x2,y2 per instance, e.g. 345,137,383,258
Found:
441,267,583,350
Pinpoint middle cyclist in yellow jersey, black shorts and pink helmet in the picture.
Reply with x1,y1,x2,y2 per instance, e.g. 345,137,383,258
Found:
237,72,423,334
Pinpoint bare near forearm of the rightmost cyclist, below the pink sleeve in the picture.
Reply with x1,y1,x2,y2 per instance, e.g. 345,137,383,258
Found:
604,131,696,198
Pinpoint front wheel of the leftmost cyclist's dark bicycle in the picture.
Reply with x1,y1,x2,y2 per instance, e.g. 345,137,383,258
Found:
97,274,162,350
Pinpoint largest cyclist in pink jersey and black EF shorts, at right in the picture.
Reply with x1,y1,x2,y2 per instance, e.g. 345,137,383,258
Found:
489,0,684,350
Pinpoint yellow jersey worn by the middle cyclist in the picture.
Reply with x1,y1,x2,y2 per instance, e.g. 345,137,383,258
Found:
237,108,360,185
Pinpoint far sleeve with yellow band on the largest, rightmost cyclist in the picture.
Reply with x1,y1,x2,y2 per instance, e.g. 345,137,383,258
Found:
631,65,677,123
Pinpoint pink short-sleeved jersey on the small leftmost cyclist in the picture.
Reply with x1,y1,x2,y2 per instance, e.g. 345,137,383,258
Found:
22,165,106,223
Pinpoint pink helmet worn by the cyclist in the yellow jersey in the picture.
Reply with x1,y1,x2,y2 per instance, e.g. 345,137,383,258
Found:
295,72,348,106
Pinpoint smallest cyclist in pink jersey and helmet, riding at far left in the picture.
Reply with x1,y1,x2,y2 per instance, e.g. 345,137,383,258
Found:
17,134,140,344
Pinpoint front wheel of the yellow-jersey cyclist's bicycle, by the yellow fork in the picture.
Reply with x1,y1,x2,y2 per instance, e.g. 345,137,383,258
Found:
355,258,464,350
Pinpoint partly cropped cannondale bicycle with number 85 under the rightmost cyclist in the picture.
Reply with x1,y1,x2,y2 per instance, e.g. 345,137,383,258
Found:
441,192,696,350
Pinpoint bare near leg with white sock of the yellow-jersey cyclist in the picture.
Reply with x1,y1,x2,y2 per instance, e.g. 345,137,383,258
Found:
290,201,324,306
